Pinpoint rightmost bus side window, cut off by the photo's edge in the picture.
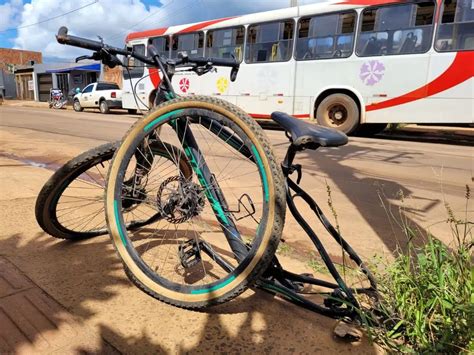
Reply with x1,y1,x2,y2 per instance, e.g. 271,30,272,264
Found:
435,0,474,52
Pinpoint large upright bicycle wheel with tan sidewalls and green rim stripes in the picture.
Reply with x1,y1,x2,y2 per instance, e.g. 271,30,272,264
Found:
106,96,286,309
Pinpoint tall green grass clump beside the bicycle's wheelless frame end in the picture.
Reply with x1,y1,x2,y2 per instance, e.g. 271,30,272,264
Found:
362,186,474,354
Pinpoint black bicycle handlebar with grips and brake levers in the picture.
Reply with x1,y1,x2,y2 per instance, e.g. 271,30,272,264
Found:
56,26,240,81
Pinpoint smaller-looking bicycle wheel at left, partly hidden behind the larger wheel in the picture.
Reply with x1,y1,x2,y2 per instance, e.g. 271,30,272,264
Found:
35,142,192,240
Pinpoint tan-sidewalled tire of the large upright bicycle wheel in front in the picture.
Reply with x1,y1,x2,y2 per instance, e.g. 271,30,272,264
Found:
105,96,285,308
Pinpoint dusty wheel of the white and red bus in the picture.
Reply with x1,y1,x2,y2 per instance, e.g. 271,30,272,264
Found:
316,94,360,134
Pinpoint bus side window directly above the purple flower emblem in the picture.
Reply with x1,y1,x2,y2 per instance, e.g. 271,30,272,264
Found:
356,0,435,57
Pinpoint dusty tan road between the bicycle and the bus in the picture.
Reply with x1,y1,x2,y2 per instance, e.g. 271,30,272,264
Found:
0,107,474,255
